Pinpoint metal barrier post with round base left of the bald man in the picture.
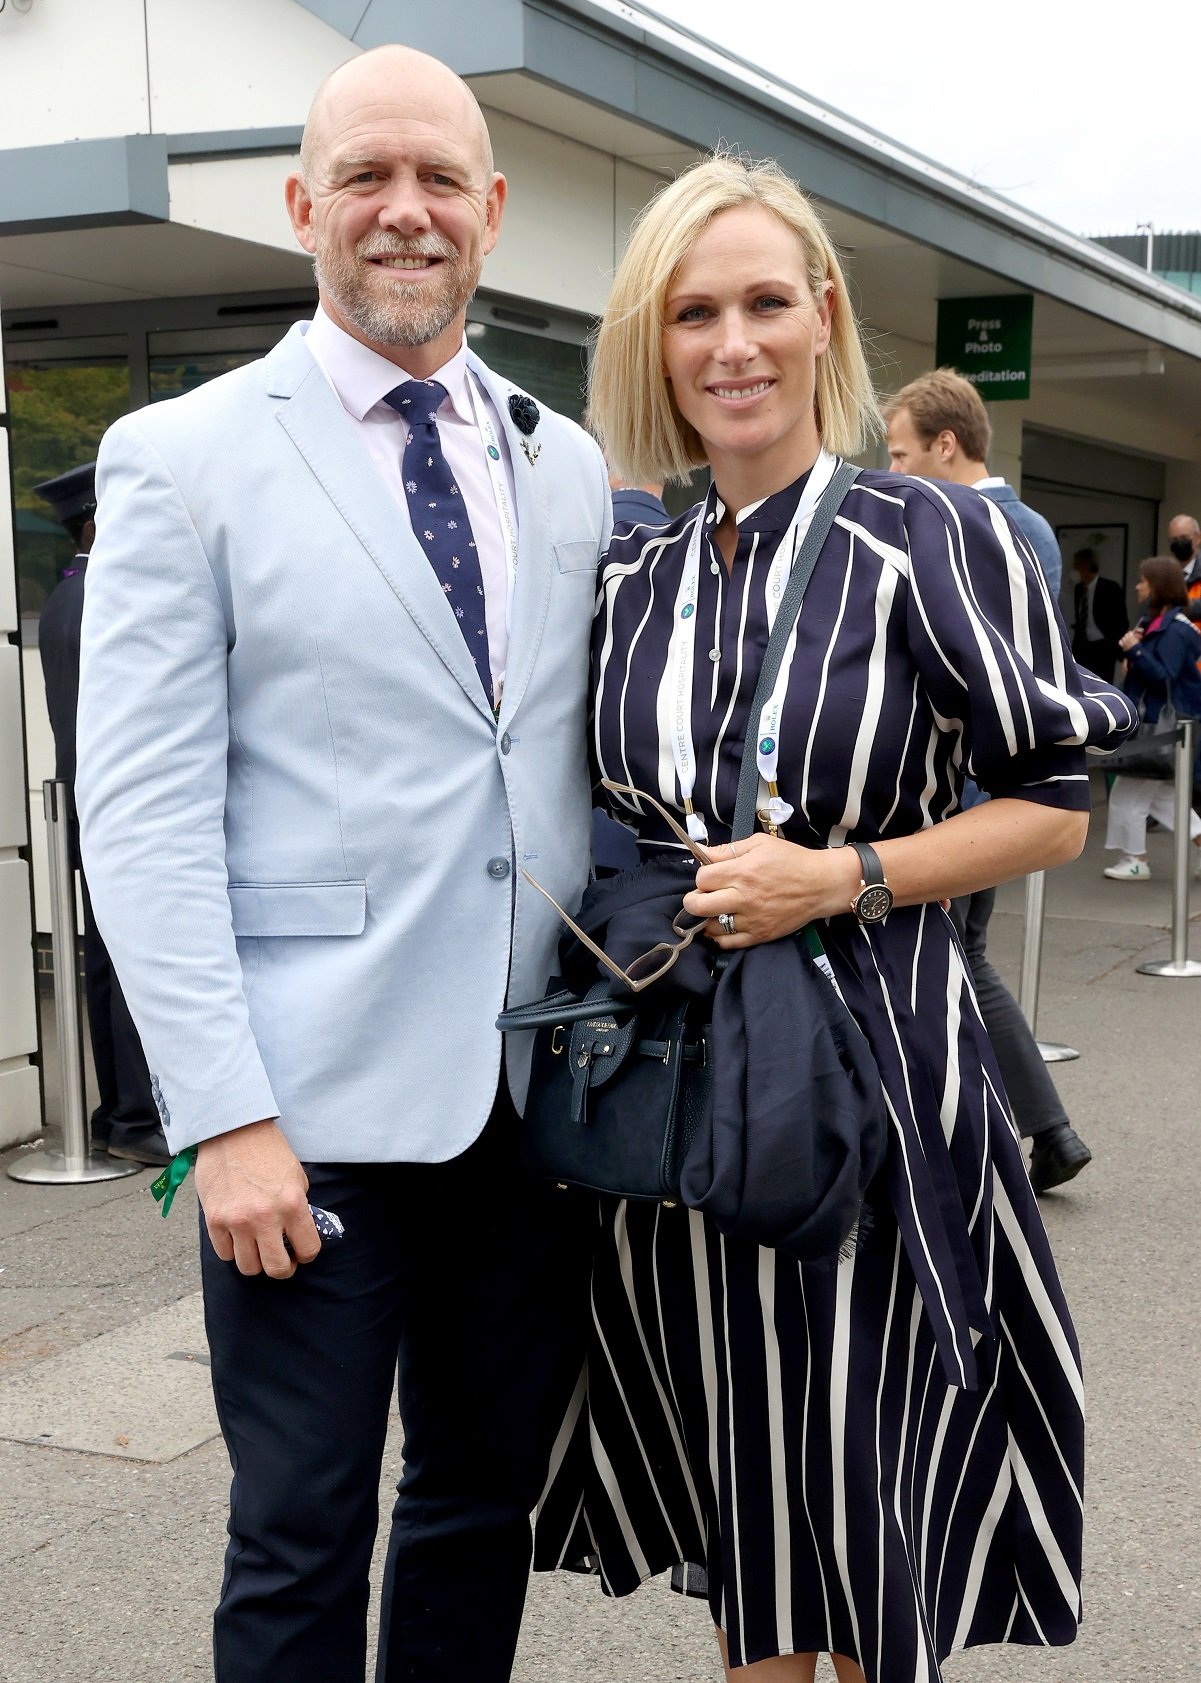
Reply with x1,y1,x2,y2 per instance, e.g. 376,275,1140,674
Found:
8,779,141,1187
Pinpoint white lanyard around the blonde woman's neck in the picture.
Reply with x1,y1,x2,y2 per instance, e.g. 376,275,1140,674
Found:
664,449,838,843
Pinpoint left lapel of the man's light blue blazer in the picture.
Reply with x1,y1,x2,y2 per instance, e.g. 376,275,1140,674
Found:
264,327,494,720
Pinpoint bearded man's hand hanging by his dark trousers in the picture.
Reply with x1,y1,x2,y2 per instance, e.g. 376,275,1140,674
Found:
197,1121,321,1279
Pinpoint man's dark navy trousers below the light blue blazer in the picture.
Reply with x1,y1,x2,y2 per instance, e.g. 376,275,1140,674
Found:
202,1094,595,1683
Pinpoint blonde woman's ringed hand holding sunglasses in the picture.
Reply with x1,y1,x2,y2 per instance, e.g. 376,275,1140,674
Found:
685,831,860,951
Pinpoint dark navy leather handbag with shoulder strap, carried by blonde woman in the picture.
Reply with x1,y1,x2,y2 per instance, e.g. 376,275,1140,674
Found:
496,463,858,1205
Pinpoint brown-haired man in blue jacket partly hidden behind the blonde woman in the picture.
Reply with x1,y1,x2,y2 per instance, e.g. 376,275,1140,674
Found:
885,369,1092,1192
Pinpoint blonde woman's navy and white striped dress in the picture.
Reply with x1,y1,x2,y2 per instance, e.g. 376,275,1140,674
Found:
535,473,1132,1683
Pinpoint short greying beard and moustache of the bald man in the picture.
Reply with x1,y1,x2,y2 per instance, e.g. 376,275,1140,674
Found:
313,234,479,347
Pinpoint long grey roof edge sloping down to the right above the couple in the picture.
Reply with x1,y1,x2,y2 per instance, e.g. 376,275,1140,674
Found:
287,0,1201,358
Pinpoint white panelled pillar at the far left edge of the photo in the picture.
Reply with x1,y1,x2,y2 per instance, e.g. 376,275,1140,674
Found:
0,306,42,1149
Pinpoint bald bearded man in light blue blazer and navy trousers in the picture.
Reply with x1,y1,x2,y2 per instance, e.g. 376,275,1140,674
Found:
79,47,609,1683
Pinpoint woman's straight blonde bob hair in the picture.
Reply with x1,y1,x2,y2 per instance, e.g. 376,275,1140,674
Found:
589,155,883,485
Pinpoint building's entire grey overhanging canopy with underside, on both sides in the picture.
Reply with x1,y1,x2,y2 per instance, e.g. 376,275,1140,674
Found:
0,0,1201,456
